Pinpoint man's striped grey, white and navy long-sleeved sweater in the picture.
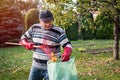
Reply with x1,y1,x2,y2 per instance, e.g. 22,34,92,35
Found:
21,23,72,69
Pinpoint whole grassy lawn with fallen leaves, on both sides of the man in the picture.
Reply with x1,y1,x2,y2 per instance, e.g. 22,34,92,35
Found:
0,40,120,80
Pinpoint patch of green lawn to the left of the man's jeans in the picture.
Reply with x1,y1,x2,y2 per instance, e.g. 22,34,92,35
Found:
0,47,32,80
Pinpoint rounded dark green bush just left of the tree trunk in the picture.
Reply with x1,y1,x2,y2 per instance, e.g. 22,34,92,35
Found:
95,13,113,39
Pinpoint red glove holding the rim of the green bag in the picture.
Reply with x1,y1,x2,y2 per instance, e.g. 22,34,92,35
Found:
62,47,72,62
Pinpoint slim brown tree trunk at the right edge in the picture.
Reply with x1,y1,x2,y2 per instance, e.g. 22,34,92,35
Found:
113,16,119,60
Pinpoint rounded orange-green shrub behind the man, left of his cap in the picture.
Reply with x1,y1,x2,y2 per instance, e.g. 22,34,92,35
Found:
25,8,39,30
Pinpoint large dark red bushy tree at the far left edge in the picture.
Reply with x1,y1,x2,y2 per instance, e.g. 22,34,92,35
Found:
0,0,24,46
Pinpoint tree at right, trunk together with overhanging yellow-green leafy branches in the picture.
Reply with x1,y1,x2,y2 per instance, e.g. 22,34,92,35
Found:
77,0,120,60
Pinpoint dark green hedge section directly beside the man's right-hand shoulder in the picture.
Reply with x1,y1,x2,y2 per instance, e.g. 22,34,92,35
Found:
66,22,78,40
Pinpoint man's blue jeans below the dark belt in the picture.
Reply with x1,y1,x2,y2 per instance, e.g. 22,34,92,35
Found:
28,67,49,80
